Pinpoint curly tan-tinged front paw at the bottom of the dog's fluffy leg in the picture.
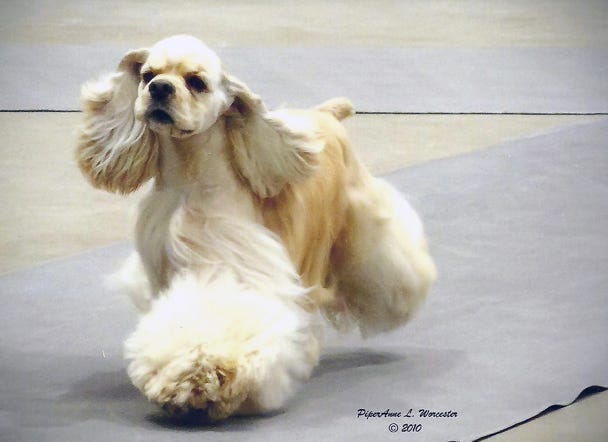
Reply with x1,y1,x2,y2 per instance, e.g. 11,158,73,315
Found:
129,348,250,420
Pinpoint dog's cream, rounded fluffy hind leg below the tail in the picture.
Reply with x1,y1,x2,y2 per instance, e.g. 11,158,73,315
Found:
334,176,436,336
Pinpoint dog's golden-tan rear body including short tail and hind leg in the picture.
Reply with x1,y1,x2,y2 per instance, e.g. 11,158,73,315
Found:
263,98,435,334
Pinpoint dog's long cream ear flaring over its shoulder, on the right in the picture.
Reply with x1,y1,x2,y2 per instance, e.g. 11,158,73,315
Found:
224,74,324,198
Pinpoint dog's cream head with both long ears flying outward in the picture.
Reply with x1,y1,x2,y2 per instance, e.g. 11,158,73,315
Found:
76,35,323,197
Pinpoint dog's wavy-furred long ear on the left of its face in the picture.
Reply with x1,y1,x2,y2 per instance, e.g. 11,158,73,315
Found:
76,49,158,193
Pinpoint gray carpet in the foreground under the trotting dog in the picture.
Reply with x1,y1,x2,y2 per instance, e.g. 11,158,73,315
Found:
0,120,608,442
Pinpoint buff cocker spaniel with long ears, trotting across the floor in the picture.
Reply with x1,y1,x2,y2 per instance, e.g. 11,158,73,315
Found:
76,36,435,419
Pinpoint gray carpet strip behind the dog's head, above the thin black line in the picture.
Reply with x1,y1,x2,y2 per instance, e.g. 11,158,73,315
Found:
0,42,608,113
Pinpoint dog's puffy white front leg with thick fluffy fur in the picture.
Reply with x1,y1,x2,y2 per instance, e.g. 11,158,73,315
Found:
126,269,319,419
